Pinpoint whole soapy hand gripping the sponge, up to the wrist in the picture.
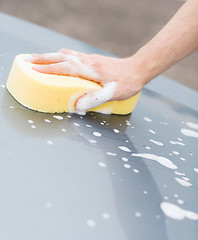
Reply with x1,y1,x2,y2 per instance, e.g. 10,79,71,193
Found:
28,49,144,111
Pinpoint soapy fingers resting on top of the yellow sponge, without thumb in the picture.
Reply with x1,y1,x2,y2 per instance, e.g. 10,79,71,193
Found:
26,49,100,82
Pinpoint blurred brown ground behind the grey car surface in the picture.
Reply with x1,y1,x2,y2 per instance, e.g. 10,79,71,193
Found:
0,0,198,90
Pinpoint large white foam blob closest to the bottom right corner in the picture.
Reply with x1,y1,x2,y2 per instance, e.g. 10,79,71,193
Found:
160,202,198,220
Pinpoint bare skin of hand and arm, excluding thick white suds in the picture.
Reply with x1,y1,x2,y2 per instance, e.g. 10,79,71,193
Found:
29,0,198,110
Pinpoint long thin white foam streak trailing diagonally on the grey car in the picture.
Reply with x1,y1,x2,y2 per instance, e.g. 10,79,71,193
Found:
131,153,177,169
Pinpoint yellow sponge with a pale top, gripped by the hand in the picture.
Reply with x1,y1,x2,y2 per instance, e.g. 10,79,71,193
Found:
7,54,139,114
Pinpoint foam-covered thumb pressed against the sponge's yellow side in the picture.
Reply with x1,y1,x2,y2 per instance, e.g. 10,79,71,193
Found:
76,82,117,111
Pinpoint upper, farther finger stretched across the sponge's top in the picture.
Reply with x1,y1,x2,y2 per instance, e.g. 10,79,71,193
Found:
26,52,65,64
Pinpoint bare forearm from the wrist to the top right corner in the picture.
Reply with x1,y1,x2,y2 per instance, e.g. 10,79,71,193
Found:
131,0,198,84
